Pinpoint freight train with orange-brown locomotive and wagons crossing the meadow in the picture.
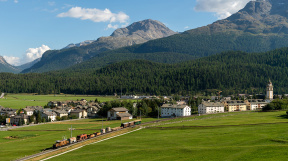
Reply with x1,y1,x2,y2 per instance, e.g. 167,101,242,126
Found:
53,120,141,149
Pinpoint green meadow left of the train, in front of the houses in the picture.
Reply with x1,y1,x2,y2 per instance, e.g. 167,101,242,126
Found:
0,118,160,161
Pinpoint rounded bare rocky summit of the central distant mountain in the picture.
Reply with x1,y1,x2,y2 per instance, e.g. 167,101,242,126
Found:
111,19,175,40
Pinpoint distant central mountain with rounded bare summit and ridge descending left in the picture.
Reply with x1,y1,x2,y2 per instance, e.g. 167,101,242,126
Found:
23,19,176,73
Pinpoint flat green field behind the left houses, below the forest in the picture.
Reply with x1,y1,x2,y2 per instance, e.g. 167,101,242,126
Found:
0,94,117,109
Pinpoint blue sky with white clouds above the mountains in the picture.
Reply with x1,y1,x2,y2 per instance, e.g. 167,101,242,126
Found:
0,0,249,65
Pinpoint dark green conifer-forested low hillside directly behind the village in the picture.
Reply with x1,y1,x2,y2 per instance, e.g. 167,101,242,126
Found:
0,48,288,95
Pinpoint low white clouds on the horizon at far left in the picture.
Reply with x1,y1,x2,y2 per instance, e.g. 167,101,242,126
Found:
3,45,50,66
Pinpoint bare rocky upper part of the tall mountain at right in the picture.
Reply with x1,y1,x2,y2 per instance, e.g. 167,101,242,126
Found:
210,0,288,34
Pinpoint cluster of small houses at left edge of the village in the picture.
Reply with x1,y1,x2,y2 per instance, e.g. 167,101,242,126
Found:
0,99,101,125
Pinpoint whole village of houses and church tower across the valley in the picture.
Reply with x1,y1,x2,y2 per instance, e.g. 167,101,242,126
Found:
0,81,273,127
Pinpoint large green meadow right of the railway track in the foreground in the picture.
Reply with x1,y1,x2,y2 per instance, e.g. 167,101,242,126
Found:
53,112,288,161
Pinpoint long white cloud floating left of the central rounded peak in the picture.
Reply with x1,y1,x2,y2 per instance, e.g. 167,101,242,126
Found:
57,7,129,29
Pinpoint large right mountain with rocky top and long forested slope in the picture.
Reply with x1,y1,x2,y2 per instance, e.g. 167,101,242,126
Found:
60,0,288,71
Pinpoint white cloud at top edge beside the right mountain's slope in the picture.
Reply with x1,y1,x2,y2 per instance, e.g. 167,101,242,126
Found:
194,0,250,19
